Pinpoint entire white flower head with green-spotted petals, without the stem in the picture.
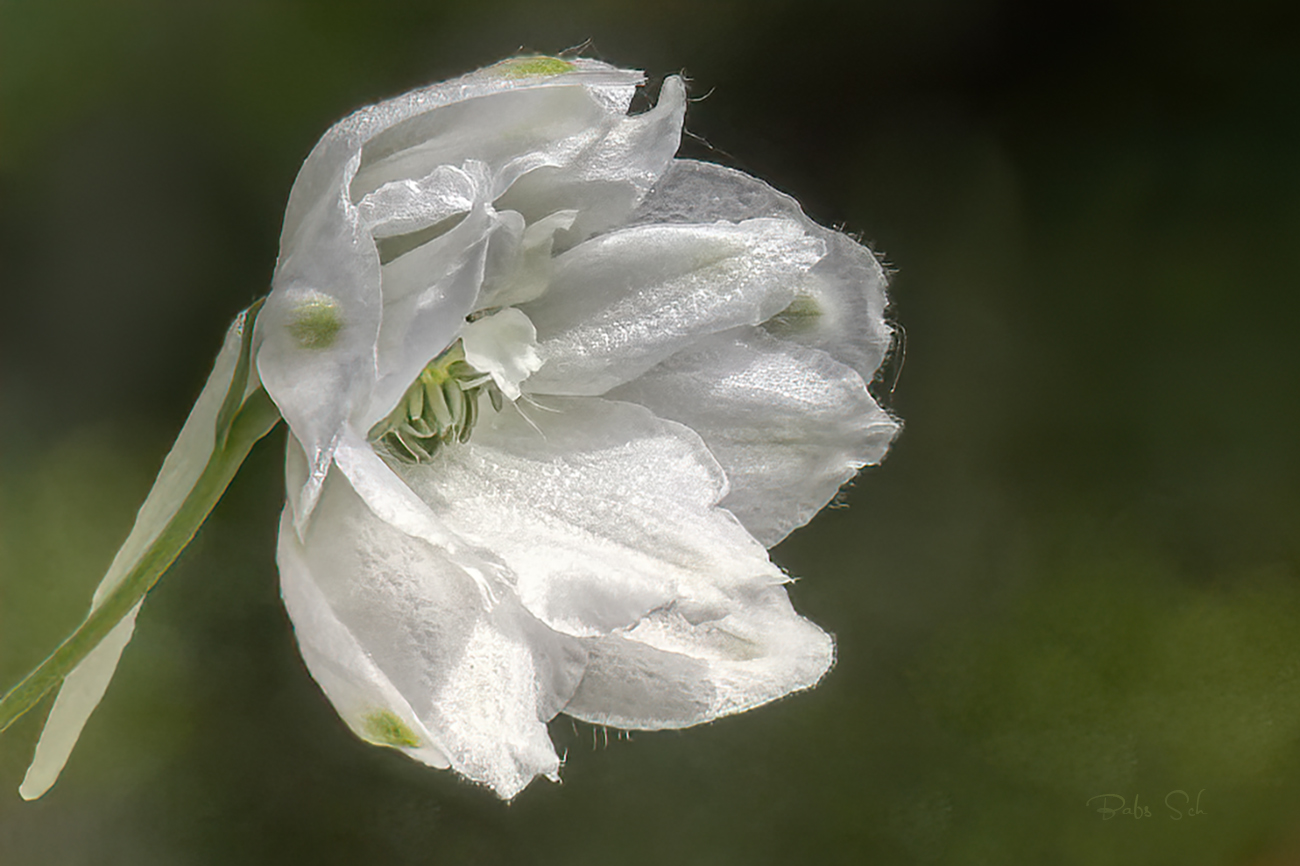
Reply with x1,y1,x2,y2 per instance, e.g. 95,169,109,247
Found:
257,57,898,798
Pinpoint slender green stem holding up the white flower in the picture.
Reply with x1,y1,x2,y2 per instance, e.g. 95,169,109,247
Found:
0,366,280,731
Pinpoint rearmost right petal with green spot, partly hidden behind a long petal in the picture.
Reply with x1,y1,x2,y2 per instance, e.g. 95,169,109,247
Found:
631,160,893,382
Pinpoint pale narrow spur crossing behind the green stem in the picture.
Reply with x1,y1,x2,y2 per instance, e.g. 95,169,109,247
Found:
21,315,259,800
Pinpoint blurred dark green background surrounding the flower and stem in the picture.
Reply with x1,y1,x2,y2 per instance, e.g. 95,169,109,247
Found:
0,0,1300,866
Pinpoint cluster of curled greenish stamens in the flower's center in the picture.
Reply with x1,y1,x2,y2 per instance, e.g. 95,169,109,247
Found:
369,339,503,463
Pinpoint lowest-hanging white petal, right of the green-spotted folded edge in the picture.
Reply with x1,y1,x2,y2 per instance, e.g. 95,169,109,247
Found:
291,457,585,798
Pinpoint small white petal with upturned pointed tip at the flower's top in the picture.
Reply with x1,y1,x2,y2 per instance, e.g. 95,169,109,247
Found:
498,75,686,246
